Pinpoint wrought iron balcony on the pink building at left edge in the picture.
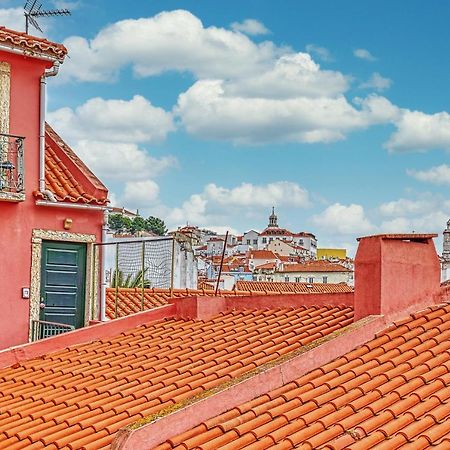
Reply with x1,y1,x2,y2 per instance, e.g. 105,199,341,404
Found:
0,133,25,202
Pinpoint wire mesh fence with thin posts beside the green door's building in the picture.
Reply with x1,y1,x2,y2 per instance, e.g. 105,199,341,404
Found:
94,237,175,318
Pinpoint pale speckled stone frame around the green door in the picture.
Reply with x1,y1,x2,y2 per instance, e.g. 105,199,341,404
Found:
28,229,97,342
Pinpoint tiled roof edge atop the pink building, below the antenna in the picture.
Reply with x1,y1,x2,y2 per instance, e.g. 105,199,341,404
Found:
0,27,67,61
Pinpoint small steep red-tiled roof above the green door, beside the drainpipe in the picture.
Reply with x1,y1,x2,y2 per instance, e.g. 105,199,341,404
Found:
35,124,109,205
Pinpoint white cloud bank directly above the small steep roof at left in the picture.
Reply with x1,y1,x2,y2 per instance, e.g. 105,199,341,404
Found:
48,95,177,208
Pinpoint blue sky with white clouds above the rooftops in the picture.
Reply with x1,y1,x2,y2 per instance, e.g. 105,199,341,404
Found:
0,0,450,250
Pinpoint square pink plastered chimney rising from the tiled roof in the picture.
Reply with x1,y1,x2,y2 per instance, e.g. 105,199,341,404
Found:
355,234,440,320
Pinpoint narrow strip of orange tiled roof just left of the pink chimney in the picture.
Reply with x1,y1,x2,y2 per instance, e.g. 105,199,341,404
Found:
236,281,353,294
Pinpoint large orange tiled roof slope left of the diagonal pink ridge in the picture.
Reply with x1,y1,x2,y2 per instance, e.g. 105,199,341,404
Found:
0,306,354,450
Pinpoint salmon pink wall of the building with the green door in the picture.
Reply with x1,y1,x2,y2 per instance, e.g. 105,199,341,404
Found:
0,51,103,348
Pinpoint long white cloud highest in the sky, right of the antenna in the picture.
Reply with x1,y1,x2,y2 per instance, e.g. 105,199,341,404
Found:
62,10,281,81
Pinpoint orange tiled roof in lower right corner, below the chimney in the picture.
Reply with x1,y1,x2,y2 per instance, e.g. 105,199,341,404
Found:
156,305,450,450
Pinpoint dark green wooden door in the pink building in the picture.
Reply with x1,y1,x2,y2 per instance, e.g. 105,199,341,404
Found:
40,241,86,328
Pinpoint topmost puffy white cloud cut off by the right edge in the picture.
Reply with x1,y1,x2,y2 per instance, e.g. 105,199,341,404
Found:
385,110,450,151
